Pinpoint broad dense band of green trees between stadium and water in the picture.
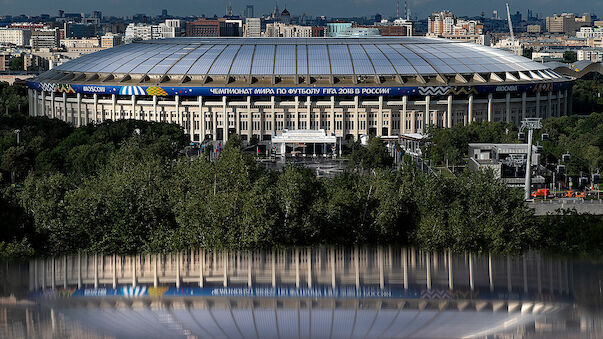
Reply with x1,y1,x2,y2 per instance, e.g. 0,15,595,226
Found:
0,117,603,255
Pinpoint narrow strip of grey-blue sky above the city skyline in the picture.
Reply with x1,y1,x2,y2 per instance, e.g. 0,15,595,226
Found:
0,0,603,17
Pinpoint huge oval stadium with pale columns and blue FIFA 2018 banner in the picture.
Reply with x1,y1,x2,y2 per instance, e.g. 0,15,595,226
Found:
28,37,572,144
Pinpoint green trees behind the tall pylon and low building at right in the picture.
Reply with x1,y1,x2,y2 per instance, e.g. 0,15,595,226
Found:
425,113,603,175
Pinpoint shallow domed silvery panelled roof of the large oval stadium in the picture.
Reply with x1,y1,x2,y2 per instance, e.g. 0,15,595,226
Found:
38,37,561,85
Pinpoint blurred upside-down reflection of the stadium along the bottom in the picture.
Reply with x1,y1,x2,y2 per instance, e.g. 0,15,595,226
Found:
0,247,603,338
